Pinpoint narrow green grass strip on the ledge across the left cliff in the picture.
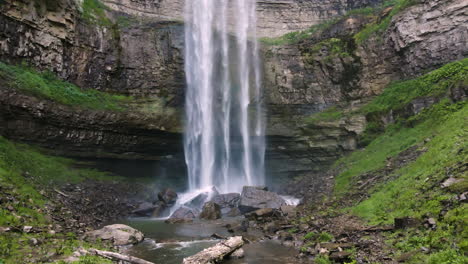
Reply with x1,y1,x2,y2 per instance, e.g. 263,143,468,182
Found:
0,62,131,111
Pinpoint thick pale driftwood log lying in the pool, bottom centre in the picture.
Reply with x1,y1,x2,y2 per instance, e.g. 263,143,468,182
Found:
183,236,244,264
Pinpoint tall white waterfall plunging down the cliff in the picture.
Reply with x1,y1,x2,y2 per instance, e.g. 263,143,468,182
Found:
184,0,265,193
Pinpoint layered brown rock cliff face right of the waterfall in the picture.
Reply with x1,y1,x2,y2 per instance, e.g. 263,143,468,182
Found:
263,0,468,182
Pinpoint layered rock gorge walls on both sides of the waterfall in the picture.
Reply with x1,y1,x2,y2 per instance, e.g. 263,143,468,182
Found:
0,0,468,186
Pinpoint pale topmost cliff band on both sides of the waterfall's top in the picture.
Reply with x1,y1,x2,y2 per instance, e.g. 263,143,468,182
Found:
100,0,381,37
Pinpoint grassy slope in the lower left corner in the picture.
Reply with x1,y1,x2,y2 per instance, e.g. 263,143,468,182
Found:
0,137,120,263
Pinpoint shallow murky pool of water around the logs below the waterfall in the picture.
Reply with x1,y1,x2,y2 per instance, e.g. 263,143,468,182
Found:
120,218,297,264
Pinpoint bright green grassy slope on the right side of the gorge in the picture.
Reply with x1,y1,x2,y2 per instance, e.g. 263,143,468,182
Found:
309,59,468,264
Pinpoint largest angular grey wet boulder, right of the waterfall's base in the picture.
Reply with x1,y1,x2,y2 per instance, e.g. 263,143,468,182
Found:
239,186,286,214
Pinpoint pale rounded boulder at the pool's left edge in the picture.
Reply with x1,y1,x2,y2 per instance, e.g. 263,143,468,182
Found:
85,224,144,246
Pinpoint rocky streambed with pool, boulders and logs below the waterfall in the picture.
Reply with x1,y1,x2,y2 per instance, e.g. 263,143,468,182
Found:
77,186,299,264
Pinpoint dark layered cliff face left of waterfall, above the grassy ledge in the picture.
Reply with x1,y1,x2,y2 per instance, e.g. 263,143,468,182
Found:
0,0,185,100
